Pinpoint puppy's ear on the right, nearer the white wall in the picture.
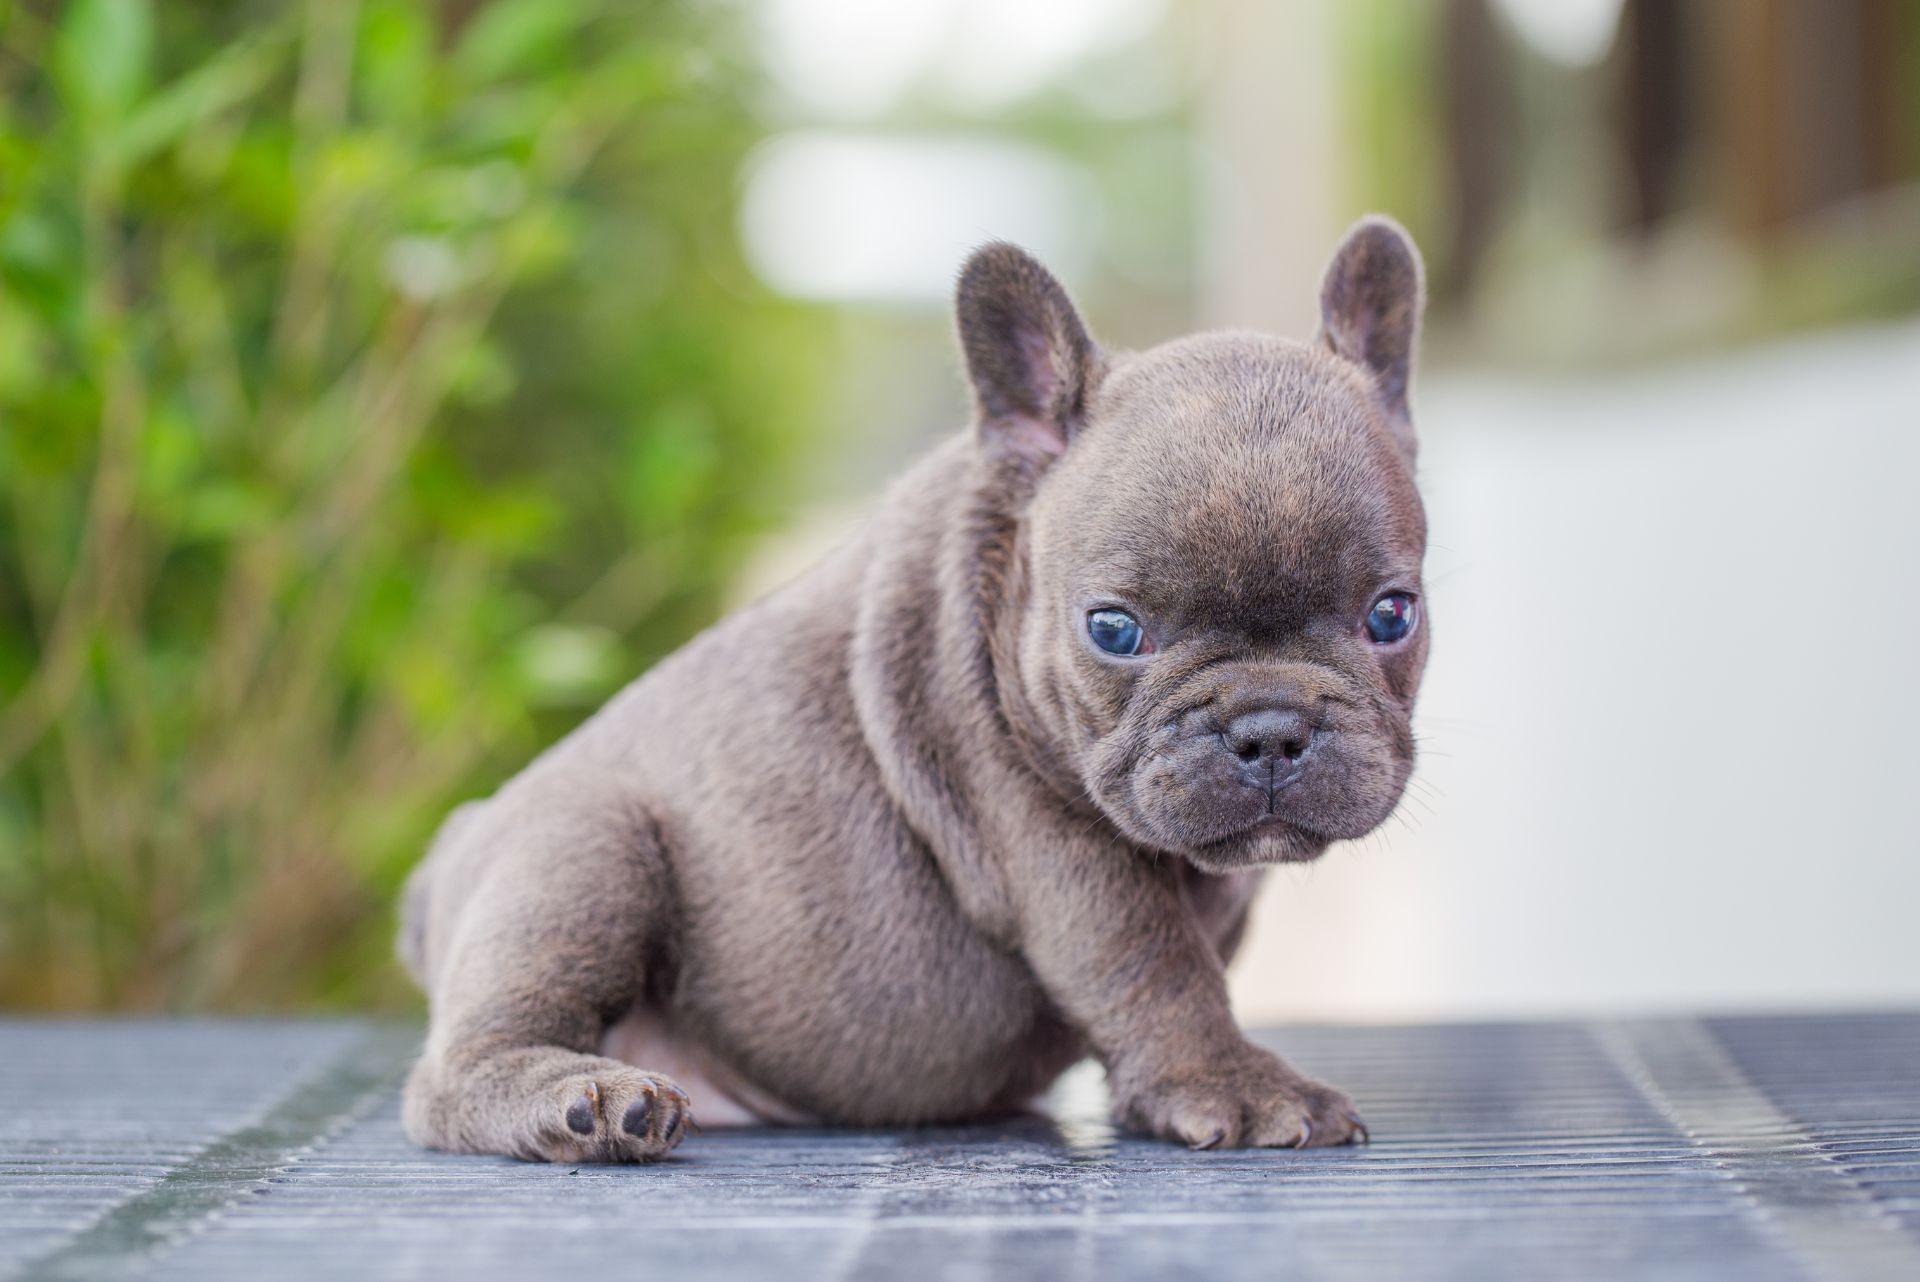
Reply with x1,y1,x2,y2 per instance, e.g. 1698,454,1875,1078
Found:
1321,215,1427,459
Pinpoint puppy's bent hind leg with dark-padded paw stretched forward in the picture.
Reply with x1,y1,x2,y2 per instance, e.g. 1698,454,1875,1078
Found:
403,764,689,1161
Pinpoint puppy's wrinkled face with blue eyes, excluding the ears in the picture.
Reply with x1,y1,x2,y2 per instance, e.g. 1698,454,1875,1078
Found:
1018,336,1428,871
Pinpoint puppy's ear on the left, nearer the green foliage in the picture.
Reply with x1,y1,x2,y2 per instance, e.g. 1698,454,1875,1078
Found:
954,242,1098,466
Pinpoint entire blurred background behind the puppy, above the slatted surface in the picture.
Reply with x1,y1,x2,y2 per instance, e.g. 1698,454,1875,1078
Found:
0,0,1920,1019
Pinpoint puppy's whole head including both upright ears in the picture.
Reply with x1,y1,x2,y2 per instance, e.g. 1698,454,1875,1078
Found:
958,219,1428,871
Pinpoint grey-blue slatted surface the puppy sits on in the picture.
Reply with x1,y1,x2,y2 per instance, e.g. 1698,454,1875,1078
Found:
0,1013,1920,1282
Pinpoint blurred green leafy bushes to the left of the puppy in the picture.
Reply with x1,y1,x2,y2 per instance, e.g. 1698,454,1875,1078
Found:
0,0,818,1008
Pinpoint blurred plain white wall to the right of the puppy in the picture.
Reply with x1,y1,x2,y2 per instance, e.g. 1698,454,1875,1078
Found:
1235,326,1920,1019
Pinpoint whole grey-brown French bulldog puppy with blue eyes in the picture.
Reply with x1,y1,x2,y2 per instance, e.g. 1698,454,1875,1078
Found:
401,219,1428,1161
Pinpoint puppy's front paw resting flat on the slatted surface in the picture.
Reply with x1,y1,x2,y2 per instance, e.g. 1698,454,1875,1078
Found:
1119,1046,1367,1148
